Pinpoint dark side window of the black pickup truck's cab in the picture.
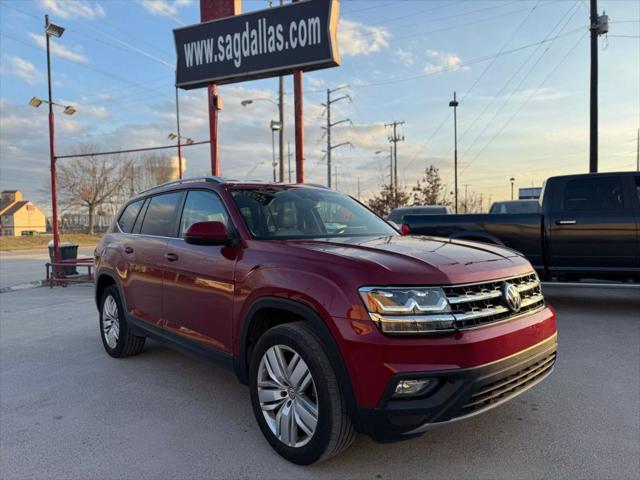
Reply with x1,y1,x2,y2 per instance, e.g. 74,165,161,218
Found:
564,177,624,210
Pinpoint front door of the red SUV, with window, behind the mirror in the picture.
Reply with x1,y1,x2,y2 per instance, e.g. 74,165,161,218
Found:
163,189,238,353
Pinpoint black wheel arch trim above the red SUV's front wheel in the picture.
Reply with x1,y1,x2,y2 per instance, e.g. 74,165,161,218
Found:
234,297,358,426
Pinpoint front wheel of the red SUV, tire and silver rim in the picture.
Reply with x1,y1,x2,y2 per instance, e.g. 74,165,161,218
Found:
249,322,355,465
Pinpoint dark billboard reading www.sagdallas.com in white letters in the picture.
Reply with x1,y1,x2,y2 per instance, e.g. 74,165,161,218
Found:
173,0,340,89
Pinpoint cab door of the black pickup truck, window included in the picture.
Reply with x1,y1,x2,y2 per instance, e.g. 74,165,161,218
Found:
548,174,637,273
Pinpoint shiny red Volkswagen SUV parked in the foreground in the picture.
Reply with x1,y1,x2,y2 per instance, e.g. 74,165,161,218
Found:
95,177,557,464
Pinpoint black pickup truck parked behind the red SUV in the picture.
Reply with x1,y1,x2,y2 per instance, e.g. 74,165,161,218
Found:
402,172,640,280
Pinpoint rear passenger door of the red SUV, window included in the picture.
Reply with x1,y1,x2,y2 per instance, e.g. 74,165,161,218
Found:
125,192,183,325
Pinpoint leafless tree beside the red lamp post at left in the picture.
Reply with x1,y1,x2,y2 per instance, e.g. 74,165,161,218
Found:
57,145,132,234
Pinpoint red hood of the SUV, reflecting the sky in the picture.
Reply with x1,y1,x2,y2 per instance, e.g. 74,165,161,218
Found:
287,235,532,281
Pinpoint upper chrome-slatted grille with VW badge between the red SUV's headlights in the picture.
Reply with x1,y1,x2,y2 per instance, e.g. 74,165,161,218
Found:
443,273,544,329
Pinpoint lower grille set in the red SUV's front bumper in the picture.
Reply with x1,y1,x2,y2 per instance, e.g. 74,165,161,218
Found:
462,352,556,415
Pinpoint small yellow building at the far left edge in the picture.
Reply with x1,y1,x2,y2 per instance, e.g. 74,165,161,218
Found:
0,190,47,236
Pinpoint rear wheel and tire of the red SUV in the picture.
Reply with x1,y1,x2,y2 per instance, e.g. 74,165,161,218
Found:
99,285,146,358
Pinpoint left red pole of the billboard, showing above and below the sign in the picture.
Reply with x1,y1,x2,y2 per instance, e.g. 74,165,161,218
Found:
200,0,242,176
